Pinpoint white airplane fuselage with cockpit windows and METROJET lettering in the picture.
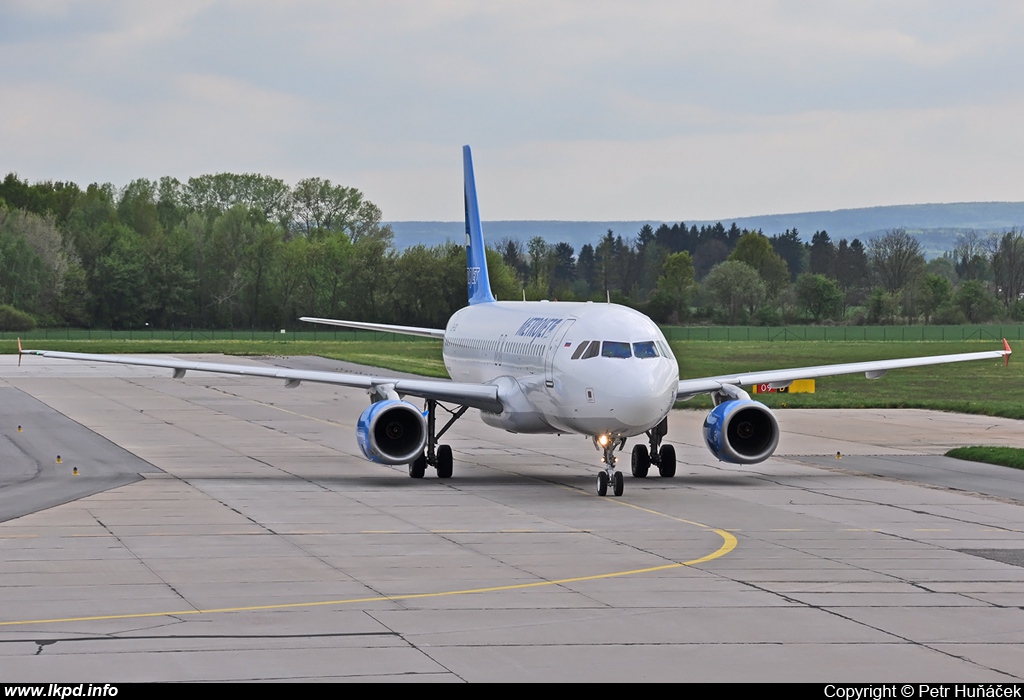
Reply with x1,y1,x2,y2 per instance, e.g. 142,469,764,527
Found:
443,302,679,438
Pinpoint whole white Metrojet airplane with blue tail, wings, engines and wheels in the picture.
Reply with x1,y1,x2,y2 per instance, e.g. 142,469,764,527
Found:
18,146,1011,496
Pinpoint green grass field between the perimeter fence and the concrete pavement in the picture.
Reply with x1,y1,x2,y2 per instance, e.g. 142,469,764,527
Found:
0,339,1024,420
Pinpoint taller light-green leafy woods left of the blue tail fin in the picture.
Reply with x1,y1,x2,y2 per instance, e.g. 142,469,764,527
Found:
0,173,518,329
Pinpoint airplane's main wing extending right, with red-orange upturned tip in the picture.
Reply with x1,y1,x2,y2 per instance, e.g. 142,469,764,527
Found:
676,339,1013,401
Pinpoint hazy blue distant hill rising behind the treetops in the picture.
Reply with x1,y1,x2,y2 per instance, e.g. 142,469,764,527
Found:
390,202,1024,258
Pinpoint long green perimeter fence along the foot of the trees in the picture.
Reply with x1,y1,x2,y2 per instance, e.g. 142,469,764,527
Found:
0,323,1024,342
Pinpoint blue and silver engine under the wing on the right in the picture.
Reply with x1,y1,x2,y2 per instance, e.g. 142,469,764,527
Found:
703,399,778,465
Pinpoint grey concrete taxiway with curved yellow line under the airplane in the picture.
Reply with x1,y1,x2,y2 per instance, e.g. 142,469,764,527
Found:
0,358,1024,682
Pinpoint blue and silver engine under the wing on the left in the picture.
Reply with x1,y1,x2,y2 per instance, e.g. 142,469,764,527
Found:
355,399,427,465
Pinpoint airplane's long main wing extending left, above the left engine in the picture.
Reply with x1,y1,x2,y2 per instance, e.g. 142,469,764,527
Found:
17,341,503,413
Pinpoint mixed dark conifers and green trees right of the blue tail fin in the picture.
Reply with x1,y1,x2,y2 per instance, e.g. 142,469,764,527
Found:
498,223,1024,325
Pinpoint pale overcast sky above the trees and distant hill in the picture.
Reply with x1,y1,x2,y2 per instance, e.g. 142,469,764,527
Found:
0,0,1024,221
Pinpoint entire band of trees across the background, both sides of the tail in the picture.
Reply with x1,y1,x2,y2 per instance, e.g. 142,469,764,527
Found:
0,173,1024,330
